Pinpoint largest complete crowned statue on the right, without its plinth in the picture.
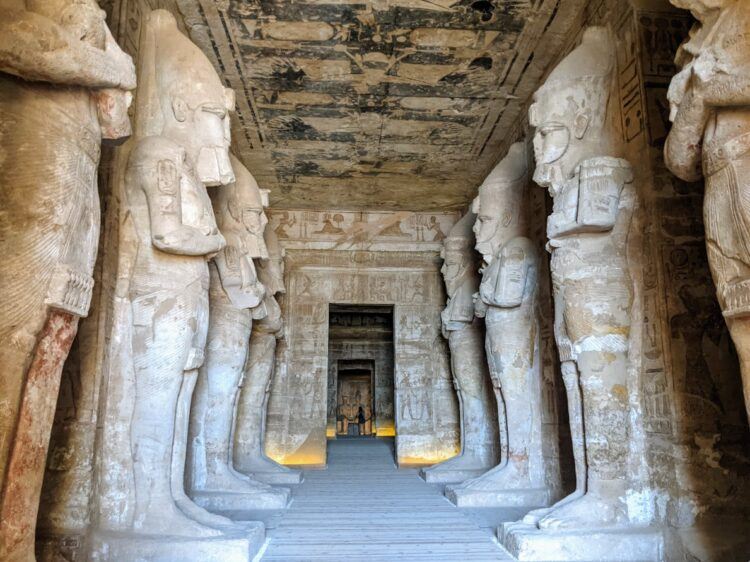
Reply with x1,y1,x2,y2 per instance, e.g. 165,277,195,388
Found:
526,28,635,532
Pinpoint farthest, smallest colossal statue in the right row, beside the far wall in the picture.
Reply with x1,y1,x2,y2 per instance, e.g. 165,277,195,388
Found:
421,212,499,483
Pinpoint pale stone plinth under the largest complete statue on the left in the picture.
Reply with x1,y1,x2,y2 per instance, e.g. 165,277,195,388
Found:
89,523,265,562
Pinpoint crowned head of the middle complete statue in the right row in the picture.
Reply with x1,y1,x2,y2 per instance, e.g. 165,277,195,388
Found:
472,142,527,264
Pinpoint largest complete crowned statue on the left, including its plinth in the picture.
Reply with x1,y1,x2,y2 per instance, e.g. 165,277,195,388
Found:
91,10,263,561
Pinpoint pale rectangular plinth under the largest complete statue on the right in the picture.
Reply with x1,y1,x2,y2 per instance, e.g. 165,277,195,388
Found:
497,523,665,562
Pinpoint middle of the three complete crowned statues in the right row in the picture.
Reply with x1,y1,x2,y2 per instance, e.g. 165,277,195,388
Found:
446,143,551,507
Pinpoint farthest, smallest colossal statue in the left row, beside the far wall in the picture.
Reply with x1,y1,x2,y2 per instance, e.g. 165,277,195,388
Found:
234,228,302,484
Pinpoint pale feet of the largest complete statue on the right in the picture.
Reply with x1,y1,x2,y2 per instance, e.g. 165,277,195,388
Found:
539,492,628,531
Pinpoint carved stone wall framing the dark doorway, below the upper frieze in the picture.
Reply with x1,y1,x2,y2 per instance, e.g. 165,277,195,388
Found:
266,248,458,464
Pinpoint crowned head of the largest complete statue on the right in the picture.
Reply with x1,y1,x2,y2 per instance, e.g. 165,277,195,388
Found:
529,27,614,196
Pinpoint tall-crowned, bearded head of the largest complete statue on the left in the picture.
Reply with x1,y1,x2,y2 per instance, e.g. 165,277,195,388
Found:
136,10,234,185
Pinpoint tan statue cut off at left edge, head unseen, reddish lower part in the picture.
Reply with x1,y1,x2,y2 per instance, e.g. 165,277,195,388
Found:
0,0,135,561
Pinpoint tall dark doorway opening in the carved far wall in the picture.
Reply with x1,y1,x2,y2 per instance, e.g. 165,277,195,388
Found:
326,304,396,439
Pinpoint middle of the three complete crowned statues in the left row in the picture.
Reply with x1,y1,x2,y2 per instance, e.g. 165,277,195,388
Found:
189,156,289,511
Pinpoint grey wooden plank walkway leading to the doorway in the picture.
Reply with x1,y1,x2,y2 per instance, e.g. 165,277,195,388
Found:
262,438,512,562
